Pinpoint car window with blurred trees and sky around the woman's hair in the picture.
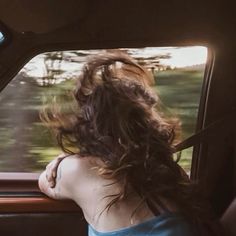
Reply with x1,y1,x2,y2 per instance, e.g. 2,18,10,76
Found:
0,46,207,172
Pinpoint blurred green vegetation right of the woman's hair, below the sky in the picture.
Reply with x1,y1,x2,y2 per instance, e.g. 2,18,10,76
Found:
155,69,204,172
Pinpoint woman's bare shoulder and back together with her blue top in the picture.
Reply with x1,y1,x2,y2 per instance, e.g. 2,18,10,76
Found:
39,155,194,236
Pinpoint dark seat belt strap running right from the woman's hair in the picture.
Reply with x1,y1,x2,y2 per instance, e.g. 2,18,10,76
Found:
174,109,236,153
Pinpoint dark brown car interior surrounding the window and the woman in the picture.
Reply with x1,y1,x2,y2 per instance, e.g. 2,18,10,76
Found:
0,0,236,236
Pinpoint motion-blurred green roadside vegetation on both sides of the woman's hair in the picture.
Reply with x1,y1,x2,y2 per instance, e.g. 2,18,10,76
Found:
0,49,204,172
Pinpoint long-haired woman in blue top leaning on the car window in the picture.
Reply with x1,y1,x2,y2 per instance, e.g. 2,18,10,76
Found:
39,51,216,236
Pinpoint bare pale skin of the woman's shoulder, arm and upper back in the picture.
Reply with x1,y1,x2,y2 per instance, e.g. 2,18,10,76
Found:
39,155,154,231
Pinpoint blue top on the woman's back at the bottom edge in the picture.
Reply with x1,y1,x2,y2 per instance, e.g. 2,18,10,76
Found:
88,213,195,236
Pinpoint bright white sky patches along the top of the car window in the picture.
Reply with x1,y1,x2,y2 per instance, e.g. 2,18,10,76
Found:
23,46,207,77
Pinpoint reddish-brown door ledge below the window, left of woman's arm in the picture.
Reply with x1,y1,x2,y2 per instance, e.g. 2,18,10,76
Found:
0,172,82,214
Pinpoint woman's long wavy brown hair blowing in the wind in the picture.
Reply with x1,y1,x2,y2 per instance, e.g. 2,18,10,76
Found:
41,51,208,222
